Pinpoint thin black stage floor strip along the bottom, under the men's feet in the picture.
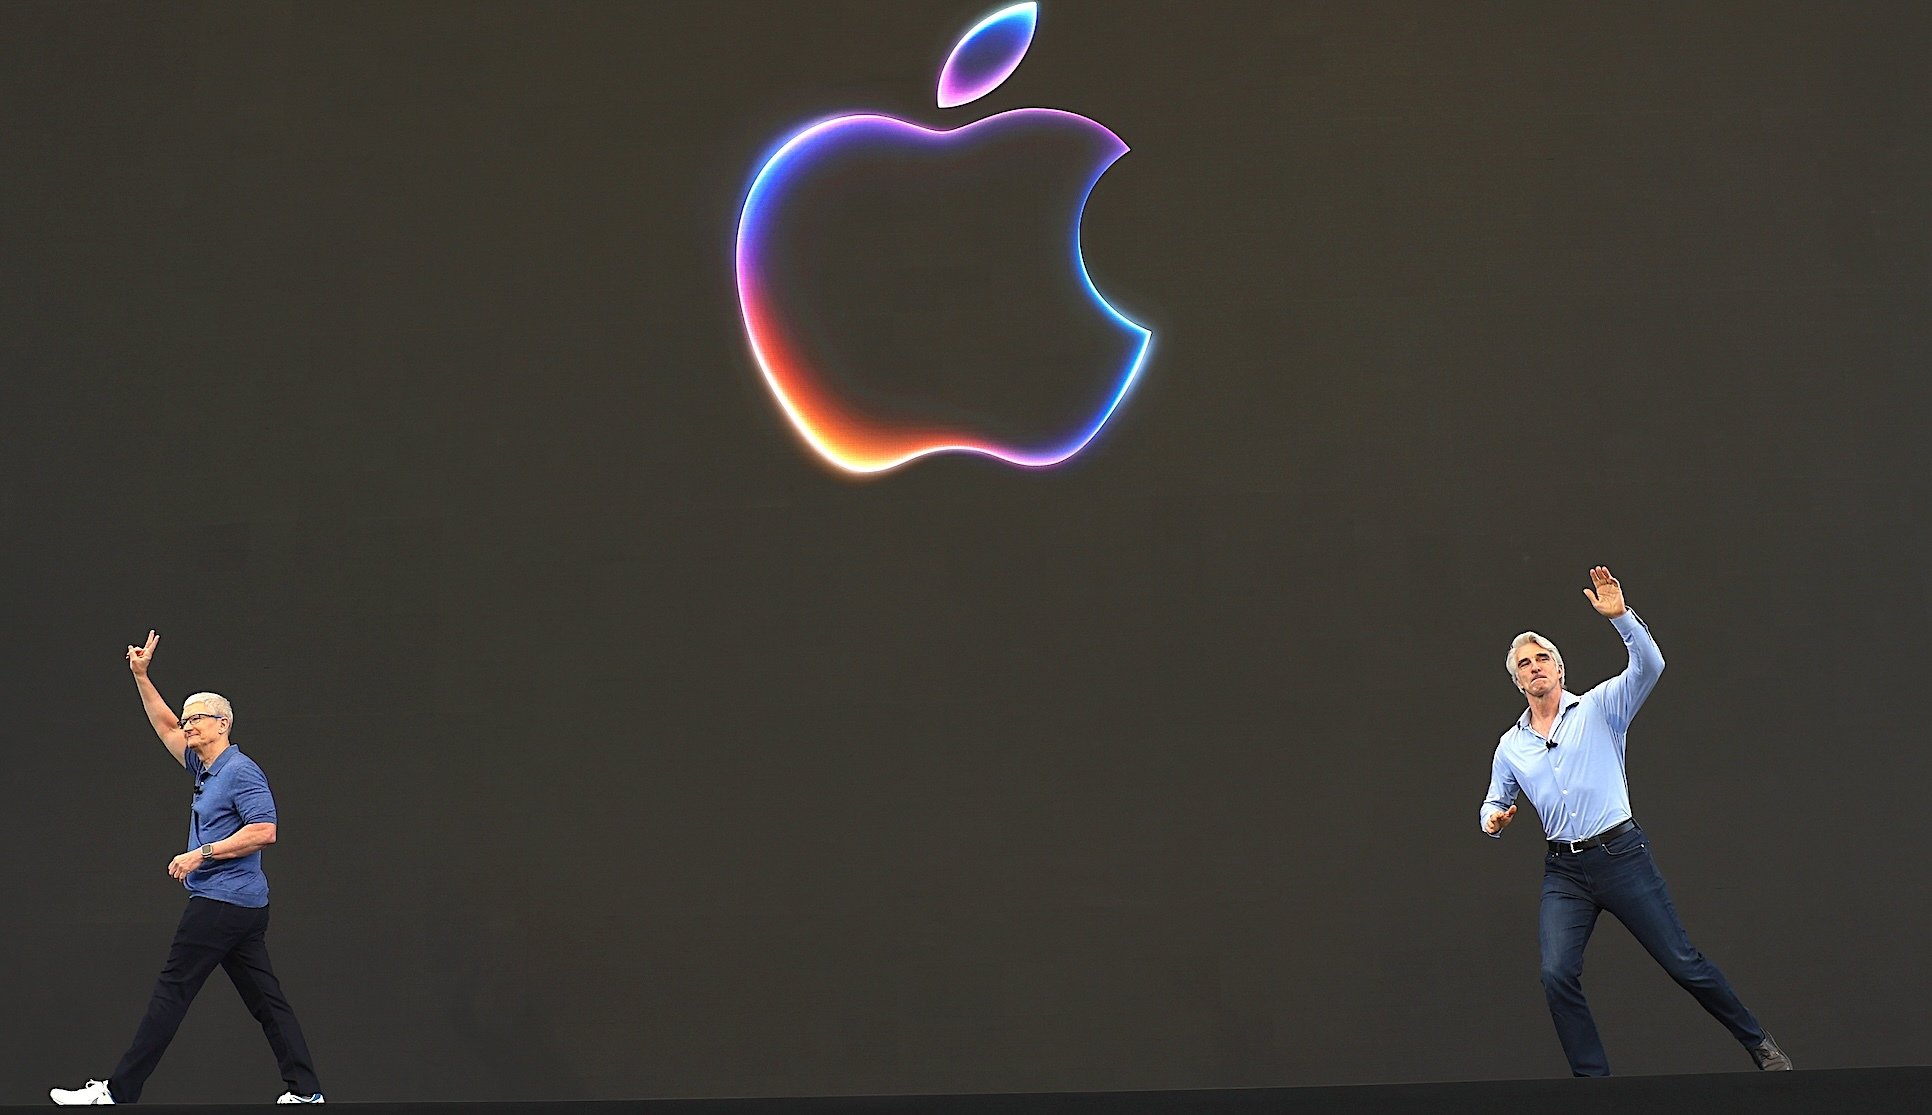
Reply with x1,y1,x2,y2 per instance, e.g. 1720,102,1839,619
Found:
0,1067,1932,1115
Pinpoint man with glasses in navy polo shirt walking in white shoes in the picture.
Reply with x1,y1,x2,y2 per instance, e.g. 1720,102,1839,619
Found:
48,632,323,1105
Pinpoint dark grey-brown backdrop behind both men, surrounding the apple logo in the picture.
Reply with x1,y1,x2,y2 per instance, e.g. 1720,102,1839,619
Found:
0,0,1932,1101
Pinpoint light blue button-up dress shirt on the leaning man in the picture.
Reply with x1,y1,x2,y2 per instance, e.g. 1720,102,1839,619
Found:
1478,609,1663,841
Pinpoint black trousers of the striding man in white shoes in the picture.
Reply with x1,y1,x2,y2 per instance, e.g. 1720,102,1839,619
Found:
108,897,323,1103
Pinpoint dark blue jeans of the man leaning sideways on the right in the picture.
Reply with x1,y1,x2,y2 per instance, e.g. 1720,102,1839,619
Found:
1540,829,1764,1076
